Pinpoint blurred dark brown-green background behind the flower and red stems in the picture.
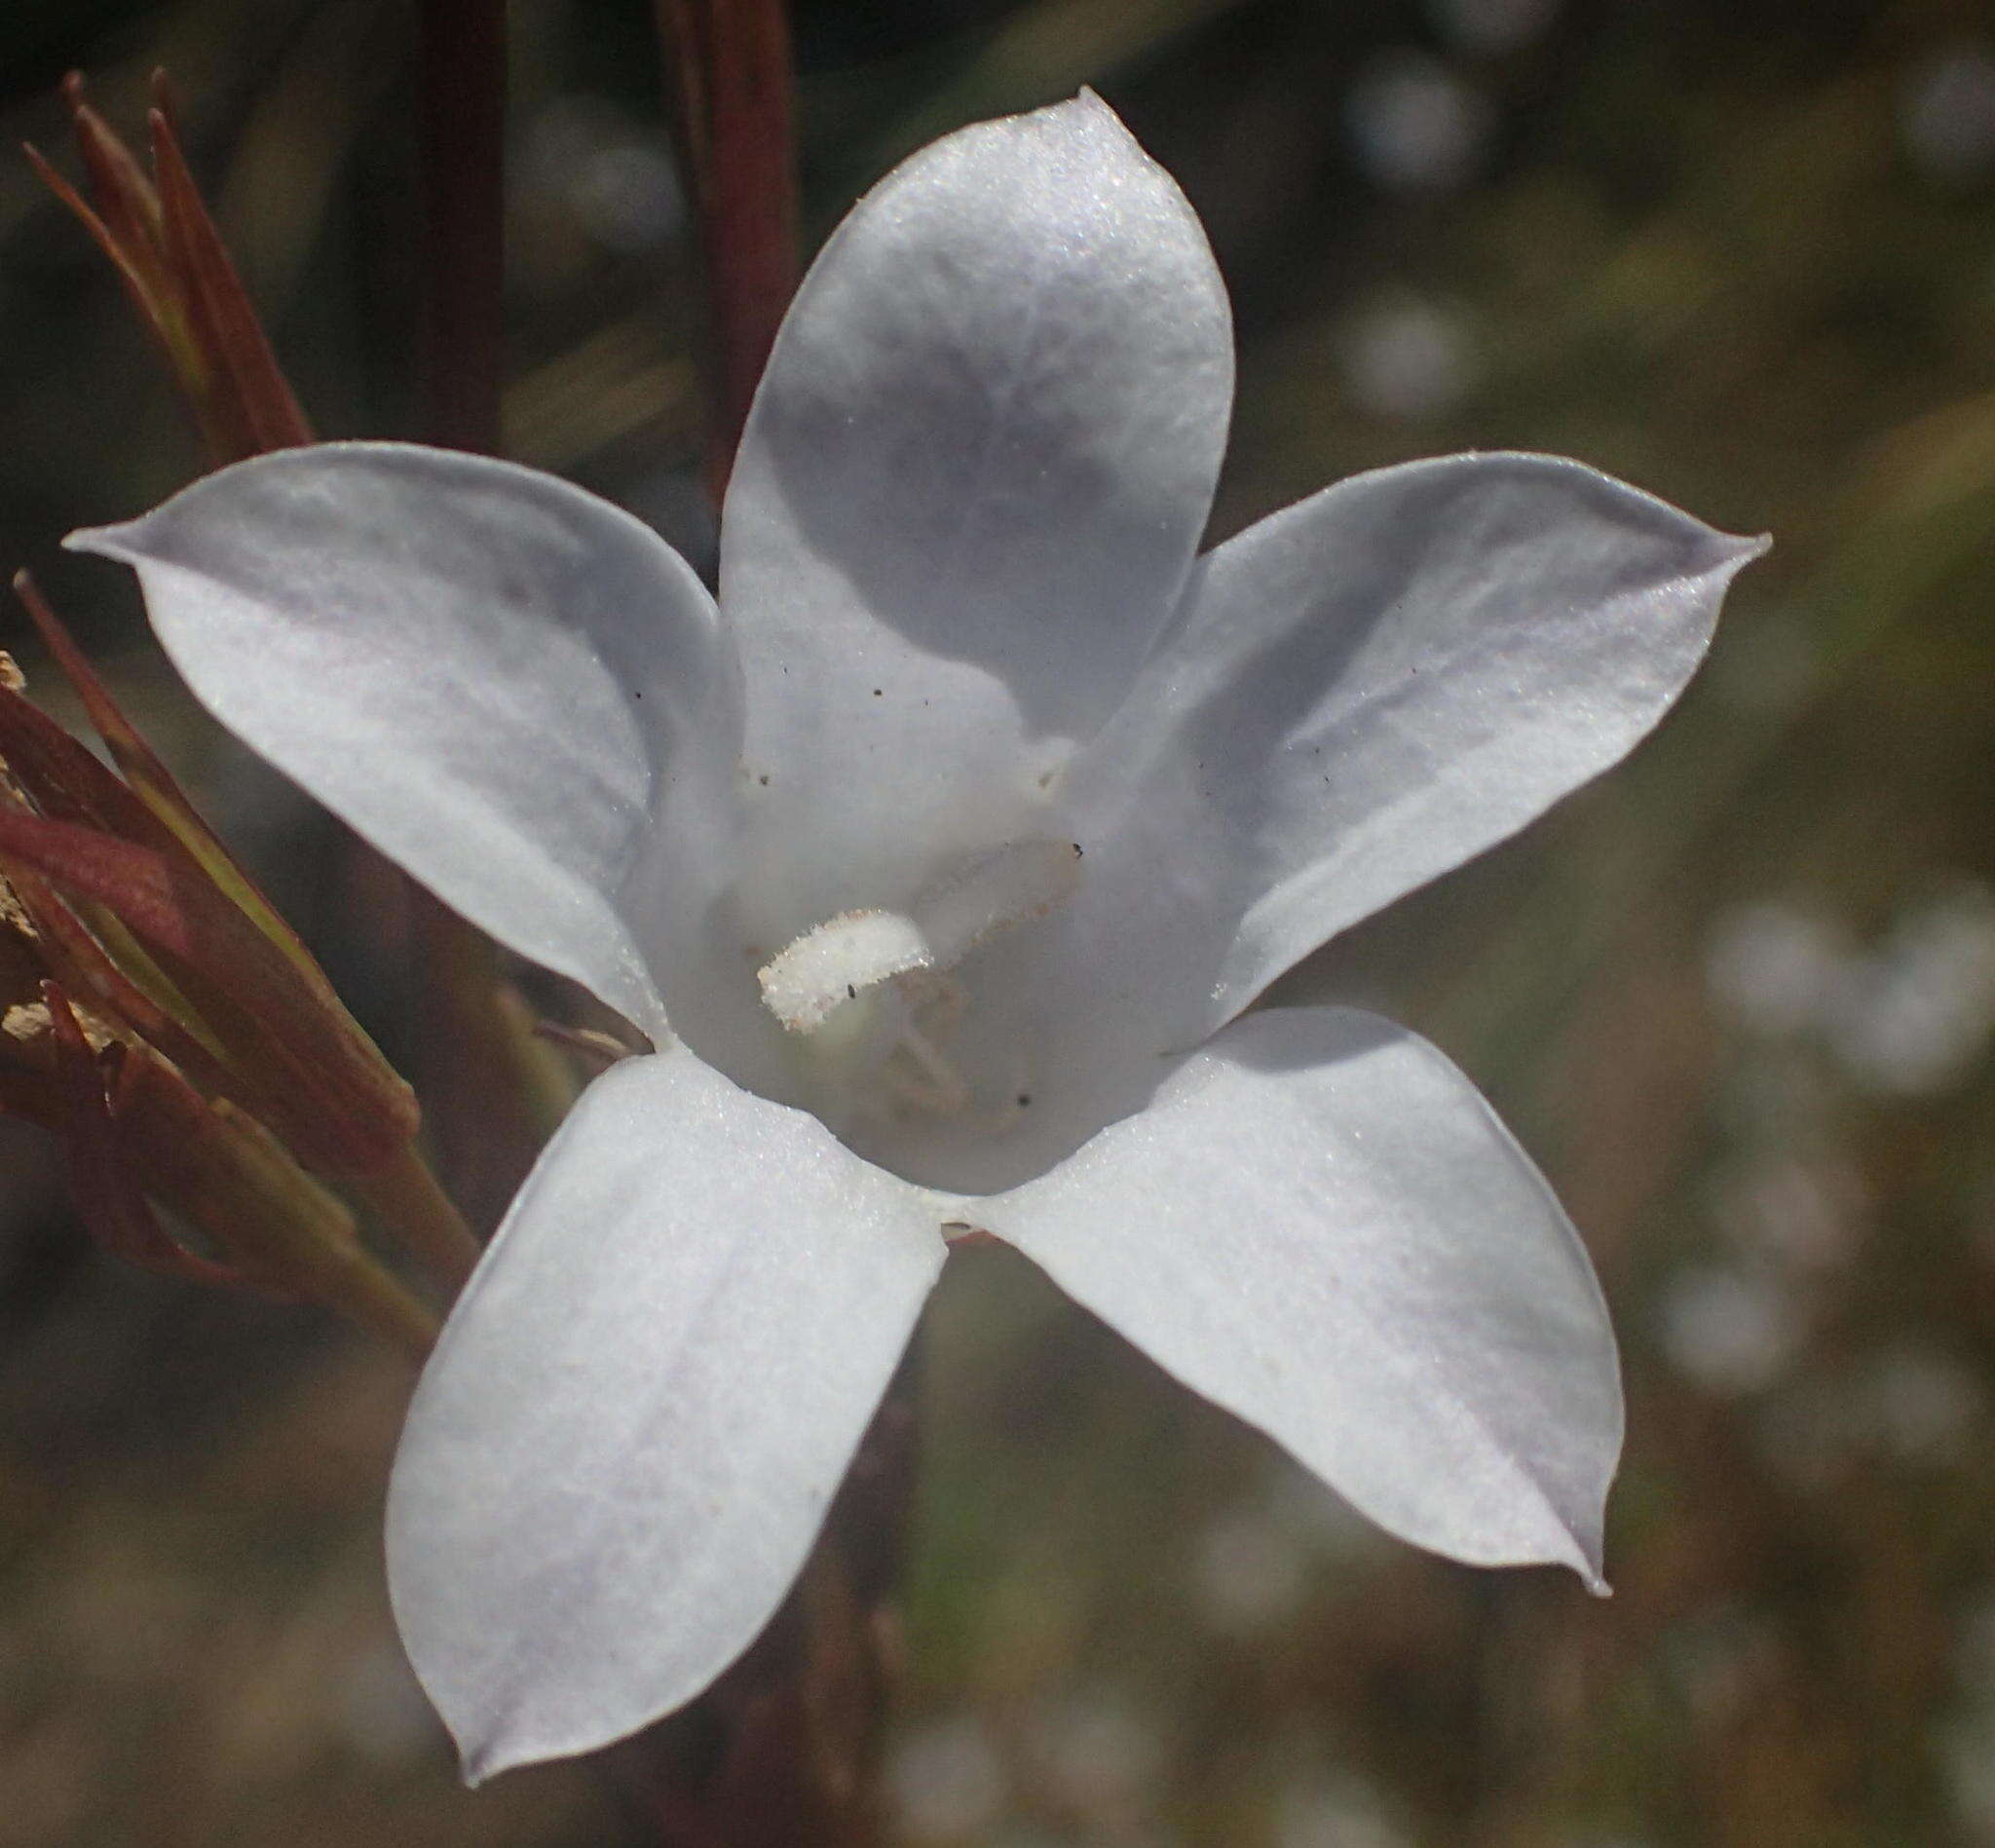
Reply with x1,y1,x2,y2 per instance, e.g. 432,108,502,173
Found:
0,0,1995,1848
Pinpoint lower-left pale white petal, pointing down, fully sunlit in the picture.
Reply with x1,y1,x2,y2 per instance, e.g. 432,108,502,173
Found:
387,1050,946,1778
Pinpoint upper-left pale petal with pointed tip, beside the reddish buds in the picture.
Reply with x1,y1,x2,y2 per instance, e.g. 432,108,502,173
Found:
70,443,740,1032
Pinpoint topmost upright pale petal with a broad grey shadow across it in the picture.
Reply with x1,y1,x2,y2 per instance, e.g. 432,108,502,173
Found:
720,95,1233,948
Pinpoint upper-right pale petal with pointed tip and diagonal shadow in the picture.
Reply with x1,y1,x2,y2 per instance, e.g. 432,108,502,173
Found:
1064,455,1763,1045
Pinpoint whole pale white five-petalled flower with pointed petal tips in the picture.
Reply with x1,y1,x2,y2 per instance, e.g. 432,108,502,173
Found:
76,95,1755,1776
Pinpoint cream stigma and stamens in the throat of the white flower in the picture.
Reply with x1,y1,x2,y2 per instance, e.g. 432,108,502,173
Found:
756,840,1081,1127
